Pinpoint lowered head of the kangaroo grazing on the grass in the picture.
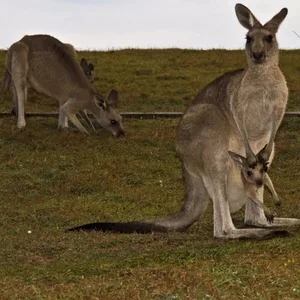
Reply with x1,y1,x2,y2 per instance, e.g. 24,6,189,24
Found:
90,90,125,137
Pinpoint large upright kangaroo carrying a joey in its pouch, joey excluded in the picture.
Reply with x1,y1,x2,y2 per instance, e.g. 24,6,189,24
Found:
69,4,300,239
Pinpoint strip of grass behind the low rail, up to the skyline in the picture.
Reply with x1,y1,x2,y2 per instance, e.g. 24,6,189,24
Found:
0,49,300,112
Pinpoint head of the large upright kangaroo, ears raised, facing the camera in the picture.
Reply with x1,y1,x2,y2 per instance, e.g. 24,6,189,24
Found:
235,4,288,64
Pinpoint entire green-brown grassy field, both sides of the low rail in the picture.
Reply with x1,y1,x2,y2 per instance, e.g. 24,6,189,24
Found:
0,49,300,300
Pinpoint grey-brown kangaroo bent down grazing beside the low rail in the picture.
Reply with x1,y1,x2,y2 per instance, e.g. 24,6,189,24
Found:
6,35,124,137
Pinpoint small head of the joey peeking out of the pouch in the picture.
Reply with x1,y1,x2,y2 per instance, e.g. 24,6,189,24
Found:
228,146,269,187
